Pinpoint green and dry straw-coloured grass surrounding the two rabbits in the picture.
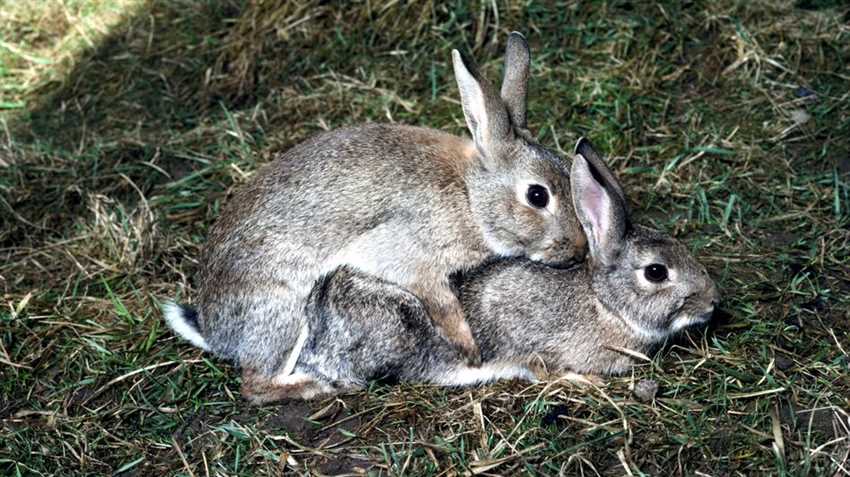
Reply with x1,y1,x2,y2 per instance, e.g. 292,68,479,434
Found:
0,0,850,476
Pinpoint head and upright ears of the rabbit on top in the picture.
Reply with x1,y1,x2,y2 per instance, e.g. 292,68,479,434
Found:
452,32,586,265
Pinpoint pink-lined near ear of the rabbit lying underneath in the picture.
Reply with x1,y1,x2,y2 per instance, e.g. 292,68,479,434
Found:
570,154,628,266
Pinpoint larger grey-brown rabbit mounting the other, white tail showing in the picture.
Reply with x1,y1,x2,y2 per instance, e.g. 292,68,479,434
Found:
164,32,586,402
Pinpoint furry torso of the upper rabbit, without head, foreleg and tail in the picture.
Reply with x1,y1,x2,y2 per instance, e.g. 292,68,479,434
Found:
198,124,491,374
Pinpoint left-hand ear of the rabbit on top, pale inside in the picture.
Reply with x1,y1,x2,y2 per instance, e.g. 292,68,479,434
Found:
452,50,513,167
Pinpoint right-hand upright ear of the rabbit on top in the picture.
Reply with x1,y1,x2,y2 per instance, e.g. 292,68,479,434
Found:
502,32,531,129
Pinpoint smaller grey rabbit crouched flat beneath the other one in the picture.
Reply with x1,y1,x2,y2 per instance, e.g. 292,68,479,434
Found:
179,141,719,399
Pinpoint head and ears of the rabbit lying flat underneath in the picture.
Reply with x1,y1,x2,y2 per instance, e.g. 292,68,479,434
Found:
570,141,719,341
